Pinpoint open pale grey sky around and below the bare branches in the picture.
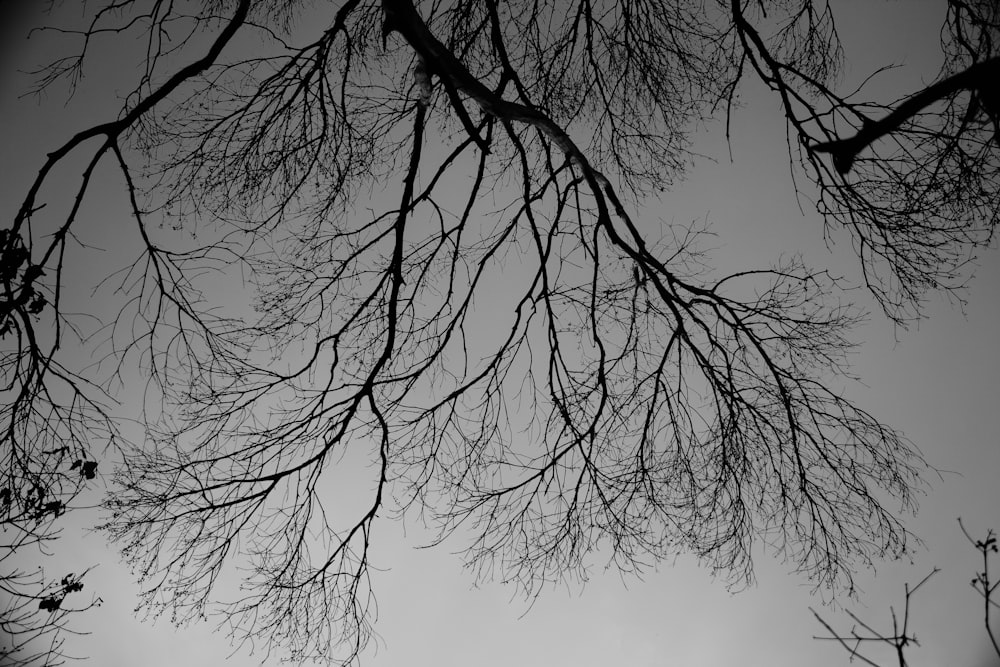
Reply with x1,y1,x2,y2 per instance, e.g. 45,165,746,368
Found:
0,0,1000,667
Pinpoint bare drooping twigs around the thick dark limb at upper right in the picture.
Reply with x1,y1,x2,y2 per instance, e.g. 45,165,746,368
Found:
760,0,1000,324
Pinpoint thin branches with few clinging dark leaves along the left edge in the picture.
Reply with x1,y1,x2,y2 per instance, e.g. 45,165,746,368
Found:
0,218,110,667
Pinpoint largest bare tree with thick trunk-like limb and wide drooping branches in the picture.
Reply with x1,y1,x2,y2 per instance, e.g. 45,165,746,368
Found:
5,0,1000,662
